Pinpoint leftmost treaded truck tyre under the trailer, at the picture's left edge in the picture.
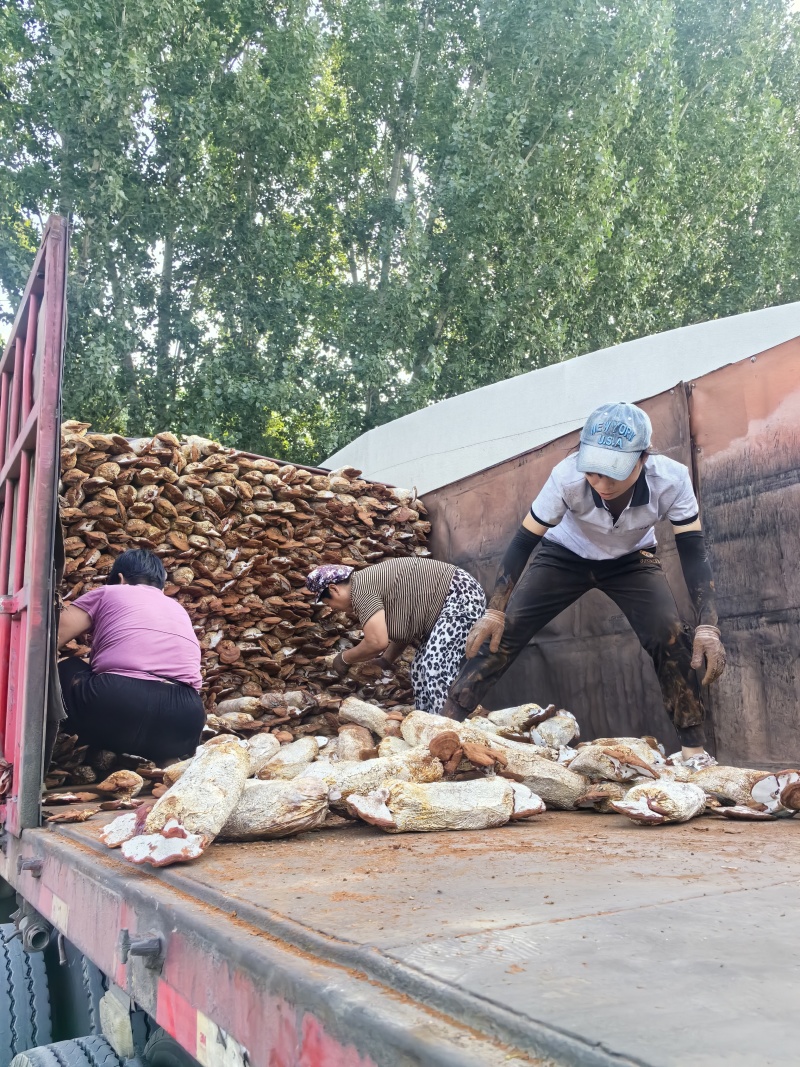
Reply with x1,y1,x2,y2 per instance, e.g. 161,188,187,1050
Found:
0,923,51,1064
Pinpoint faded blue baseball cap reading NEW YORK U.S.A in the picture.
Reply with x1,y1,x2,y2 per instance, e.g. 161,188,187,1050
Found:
577,402,653,481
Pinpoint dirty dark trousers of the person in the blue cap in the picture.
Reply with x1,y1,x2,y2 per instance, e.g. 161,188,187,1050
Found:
450,541,705,747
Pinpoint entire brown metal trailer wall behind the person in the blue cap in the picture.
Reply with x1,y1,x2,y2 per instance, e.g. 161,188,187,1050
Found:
423,339,800,767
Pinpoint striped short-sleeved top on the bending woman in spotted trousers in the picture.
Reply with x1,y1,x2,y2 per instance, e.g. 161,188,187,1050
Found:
350,556,455,644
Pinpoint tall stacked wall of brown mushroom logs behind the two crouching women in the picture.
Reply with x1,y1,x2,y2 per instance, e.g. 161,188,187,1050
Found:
48,421,430,786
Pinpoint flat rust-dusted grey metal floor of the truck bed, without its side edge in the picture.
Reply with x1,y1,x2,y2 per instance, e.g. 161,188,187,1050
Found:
26,812,800,1067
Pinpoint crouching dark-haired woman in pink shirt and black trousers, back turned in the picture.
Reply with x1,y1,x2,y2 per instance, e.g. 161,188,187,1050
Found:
59,548,206,764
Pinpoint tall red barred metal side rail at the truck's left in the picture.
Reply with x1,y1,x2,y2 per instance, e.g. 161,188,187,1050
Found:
0,216,68,834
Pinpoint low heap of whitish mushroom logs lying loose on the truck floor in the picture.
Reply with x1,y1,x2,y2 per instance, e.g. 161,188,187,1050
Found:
45,698,800,866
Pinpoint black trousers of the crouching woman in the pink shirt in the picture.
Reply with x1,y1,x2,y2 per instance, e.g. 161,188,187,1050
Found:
59,656,206,764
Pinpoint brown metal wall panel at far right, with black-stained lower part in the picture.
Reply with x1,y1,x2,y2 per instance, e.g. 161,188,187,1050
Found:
690,338,800,768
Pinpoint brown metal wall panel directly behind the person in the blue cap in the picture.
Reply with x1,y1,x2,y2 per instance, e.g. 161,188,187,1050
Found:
425,385,691,749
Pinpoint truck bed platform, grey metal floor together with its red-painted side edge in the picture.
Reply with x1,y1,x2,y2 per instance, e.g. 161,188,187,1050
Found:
0,812,800,1067
